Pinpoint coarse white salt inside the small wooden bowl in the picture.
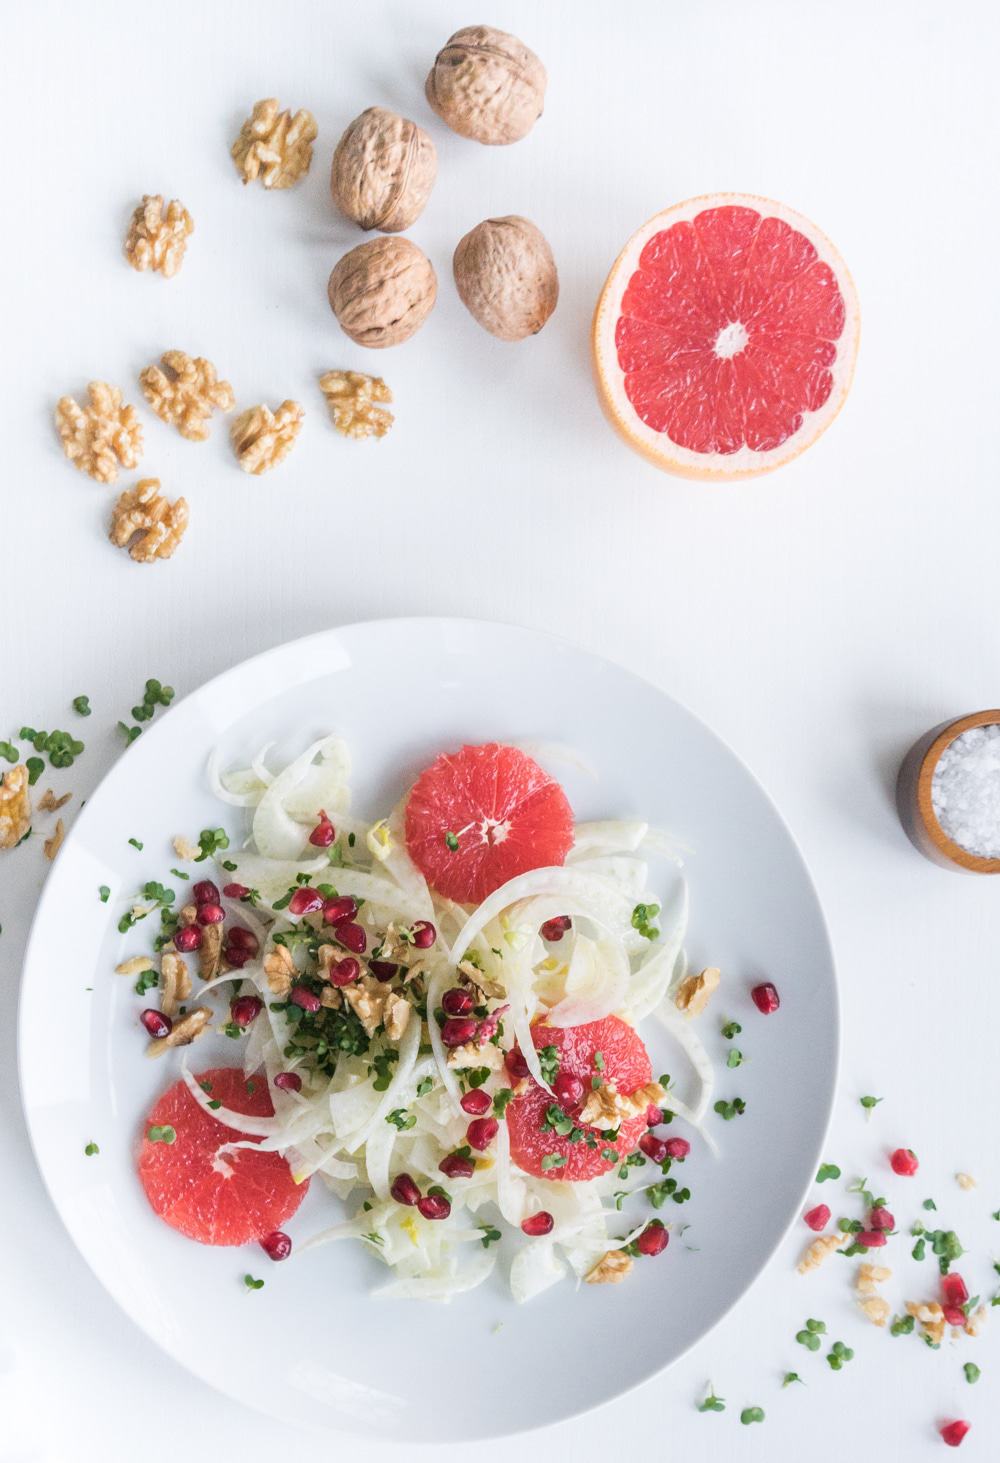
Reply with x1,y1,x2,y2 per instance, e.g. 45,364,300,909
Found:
931,721,1000,859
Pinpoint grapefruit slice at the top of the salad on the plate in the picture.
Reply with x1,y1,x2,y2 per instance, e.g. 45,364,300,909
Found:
406,742,573,904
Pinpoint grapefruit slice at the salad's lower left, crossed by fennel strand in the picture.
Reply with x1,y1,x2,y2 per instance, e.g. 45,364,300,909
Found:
139,1067,308,1245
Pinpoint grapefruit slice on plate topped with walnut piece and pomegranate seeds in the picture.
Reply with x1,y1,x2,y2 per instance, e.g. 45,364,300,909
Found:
507,1015,652,1181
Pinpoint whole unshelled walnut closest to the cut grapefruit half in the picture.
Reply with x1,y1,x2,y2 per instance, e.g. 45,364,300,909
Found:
453,214,558,341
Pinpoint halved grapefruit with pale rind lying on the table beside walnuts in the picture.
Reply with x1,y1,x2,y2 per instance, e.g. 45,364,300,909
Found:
592,193,860,480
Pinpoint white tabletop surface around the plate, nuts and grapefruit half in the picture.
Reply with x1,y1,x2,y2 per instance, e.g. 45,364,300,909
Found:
0,0,1000,1463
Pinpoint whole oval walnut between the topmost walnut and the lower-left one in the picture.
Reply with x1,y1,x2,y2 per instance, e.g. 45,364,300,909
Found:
330,107,437,234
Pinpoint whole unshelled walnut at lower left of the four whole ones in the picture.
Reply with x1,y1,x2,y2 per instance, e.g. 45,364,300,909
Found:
327,236,437,350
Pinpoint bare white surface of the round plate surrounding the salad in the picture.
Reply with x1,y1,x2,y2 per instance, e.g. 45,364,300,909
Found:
19,619,839,1443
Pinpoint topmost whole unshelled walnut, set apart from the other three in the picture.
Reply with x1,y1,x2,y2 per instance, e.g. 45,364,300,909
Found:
424,25,547,143
